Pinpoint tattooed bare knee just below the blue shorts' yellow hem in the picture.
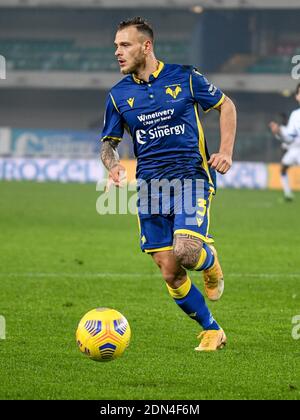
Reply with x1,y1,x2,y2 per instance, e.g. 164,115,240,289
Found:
173,233,202,270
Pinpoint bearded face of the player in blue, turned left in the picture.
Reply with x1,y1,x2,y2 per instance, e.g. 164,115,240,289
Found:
115,26,146,74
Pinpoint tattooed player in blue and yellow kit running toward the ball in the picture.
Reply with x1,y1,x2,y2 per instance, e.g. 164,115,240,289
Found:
101,17,236,351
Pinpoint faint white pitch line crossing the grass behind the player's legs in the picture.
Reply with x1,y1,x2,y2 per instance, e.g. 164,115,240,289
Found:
0,272,300,278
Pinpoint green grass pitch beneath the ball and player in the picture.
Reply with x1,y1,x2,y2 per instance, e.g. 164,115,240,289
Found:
0,182,300,400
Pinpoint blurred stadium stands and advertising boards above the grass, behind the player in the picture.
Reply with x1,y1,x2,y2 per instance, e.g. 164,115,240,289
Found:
0,0,300,188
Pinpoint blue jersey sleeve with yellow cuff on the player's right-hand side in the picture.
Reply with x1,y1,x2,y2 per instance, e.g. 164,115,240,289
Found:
190,69,225,112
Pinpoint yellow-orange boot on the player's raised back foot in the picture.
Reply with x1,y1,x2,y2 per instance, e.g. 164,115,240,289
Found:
203,245,224,301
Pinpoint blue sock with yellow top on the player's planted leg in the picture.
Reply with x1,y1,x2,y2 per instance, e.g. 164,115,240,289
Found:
167,277,220,330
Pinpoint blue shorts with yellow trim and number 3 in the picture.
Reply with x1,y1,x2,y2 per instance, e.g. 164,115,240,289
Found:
138,180,214,253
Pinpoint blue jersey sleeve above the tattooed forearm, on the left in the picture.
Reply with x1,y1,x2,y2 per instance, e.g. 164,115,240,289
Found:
101,93,124,141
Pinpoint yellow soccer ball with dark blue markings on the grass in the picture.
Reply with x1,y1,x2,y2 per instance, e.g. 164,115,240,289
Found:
76,308,131,362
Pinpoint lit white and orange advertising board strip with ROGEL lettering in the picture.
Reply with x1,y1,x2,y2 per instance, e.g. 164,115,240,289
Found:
0,158,300,191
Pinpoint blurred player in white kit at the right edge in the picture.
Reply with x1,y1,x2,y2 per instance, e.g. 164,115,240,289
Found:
269,83,300,201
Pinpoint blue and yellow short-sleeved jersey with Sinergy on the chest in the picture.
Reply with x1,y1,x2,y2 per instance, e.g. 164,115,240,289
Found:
102,62,225,187
